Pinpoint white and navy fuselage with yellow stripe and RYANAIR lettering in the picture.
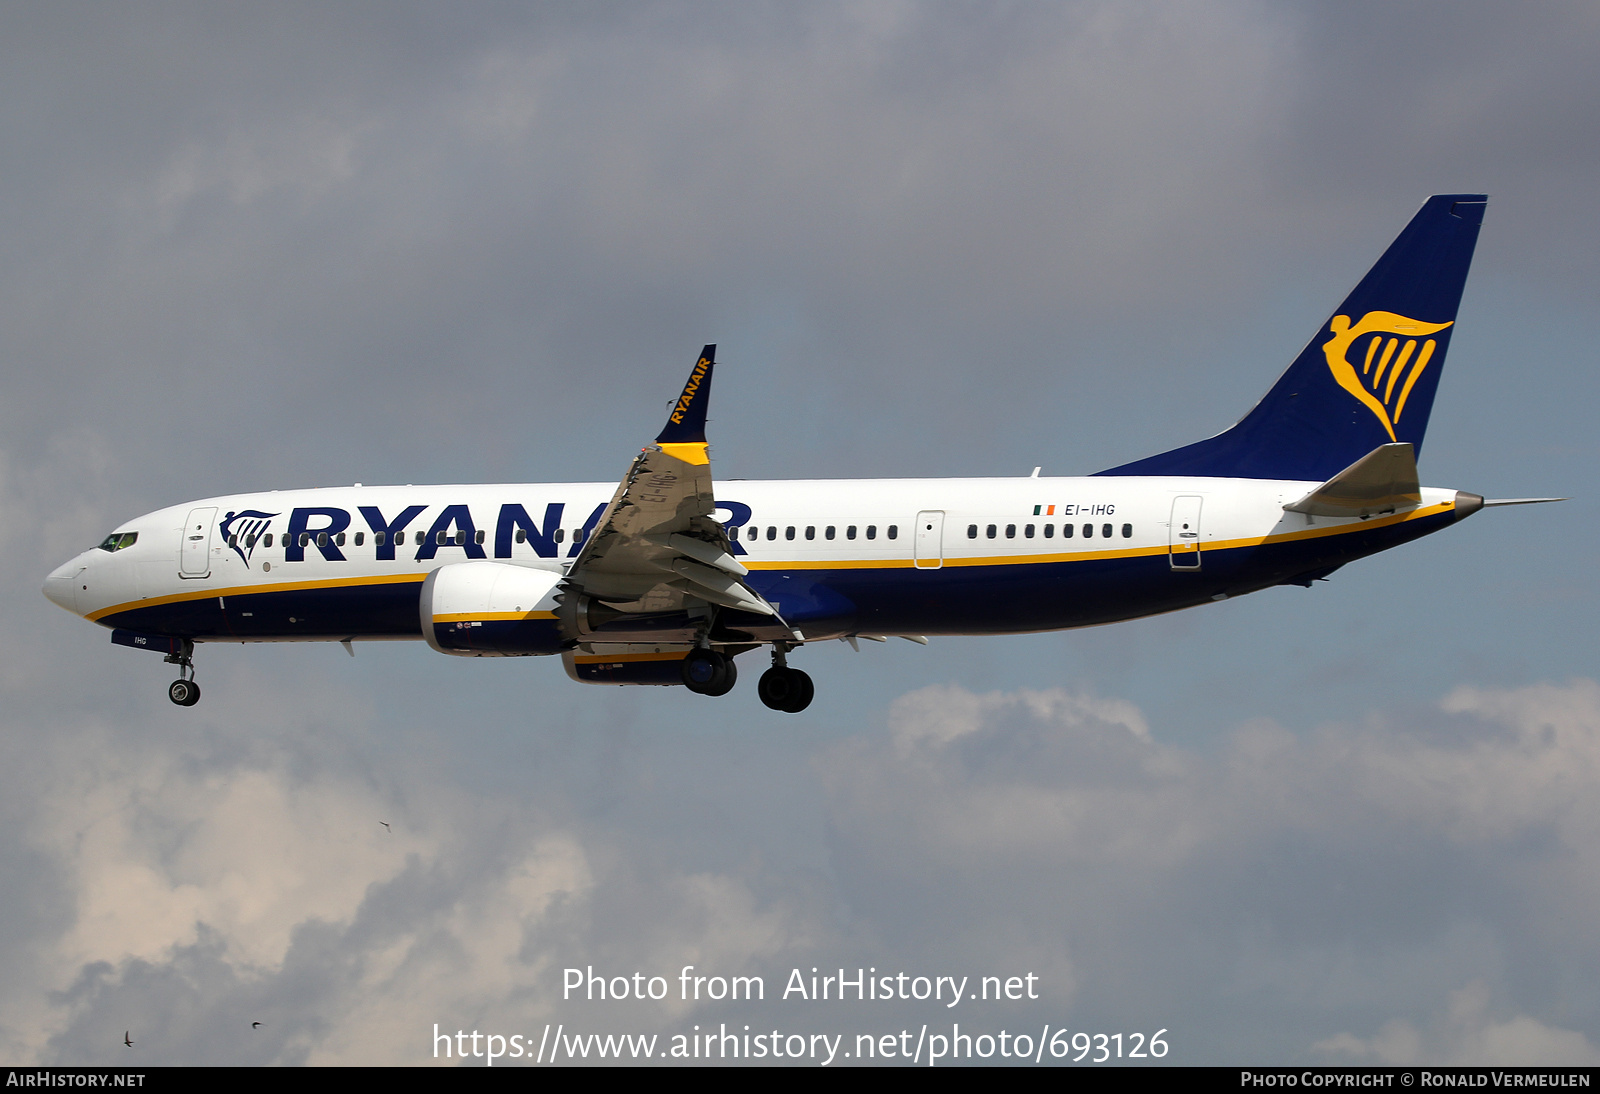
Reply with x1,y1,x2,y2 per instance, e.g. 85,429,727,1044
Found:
45,477,1456,641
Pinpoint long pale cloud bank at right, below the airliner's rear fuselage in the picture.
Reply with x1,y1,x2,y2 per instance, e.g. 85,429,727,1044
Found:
826,680,1600,867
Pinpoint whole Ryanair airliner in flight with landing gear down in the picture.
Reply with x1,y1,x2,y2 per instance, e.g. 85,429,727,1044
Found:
45,194,1555,712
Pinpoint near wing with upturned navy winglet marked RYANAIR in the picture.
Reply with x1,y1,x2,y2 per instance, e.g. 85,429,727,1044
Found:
566,345,778,616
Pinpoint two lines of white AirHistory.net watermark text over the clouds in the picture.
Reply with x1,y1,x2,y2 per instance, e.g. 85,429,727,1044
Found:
432,964,1170,1067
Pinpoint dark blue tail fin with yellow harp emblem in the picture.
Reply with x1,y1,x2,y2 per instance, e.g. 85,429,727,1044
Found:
1099,194,1488,481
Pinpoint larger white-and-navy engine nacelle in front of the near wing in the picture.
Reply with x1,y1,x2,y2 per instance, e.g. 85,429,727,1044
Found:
421,561,568,657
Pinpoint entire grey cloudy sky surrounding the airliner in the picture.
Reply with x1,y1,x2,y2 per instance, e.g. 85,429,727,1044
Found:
0,2,1600,1064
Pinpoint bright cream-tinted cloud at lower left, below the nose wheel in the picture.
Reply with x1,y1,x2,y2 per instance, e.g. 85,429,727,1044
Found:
5,726,438,1057
